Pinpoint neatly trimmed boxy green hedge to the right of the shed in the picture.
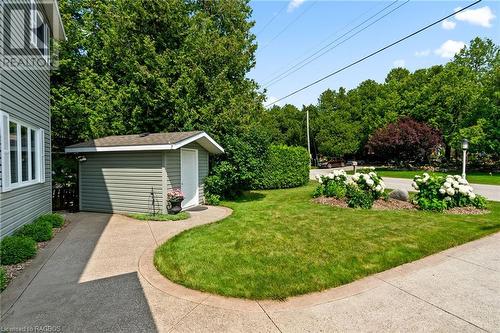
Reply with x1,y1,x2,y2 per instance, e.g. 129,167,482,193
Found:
252,145,310,189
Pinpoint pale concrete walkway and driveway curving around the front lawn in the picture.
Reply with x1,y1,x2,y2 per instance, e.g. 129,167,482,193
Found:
0,207,500,332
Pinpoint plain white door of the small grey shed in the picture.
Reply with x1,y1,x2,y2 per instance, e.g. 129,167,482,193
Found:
181,149,198,208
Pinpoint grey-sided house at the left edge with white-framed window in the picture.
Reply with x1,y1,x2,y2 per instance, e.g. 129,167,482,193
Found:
0,0,65,237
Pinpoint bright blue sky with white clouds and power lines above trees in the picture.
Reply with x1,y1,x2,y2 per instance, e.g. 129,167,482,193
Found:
249,0,500,107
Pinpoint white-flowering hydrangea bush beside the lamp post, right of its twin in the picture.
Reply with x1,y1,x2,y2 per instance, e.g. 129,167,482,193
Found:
412,173,486,211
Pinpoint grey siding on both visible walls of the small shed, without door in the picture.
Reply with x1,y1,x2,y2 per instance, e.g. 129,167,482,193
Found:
79,143,208,213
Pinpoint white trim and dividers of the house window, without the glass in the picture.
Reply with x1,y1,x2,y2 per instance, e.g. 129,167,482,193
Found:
0,111,45,192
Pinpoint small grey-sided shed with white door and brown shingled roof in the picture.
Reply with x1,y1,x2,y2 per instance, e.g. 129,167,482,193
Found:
66,131,224,213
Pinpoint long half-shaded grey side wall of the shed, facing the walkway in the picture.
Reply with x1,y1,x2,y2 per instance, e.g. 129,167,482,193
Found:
80,151,163,213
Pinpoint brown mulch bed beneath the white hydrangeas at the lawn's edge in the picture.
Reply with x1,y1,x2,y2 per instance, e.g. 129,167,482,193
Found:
312,197,490,215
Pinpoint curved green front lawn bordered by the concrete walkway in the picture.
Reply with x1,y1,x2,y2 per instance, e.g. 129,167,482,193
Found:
154,183,500,299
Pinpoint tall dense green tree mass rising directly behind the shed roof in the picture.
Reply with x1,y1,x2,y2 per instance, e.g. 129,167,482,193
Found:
52,0,262,147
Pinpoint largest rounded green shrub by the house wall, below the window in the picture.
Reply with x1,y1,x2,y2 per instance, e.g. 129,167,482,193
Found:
0,236,37,265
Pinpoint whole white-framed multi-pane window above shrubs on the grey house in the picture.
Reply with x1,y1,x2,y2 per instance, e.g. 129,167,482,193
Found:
0,112,45,192
